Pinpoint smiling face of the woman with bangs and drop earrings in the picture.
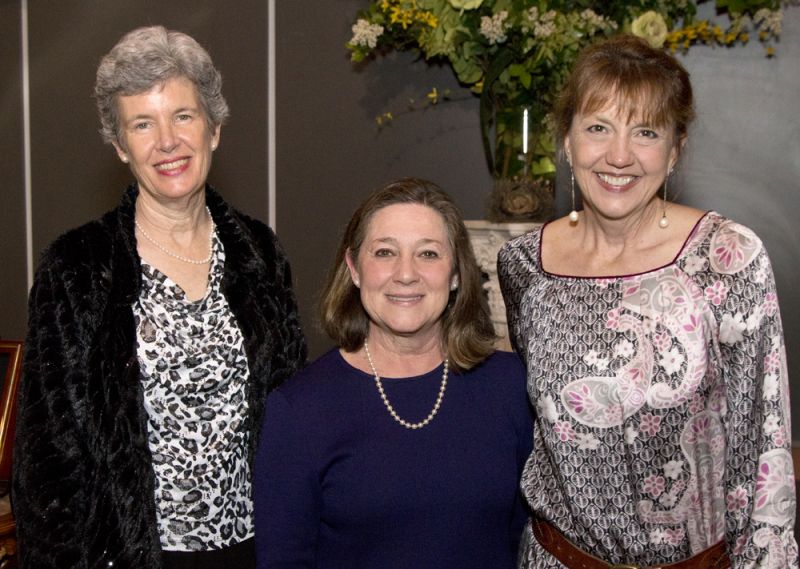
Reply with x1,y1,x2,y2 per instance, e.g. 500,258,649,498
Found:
564,99,679,221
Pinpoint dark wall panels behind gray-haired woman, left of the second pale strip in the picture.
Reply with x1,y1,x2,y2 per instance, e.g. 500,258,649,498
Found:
0,0,267,339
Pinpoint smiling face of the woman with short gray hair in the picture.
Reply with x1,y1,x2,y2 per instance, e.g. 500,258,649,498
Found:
114,77,220,203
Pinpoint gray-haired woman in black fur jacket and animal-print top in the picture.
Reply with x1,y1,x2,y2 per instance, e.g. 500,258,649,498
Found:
13,27,306,569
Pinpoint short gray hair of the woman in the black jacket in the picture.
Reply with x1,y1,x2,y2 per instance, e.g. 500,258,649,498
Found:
94,26,229,146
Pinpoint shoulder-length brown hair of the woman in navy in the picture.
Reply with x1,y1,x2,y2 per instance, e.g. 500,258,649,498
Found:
320,178,496,370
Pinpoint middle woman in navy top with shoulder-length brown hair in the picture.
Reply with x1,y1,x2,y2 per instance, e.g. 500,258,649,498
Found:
255,179,532,569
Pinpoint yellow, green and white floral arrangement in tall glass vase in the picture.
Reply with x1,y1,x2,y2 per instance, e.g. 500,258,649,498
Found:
347,0,781,219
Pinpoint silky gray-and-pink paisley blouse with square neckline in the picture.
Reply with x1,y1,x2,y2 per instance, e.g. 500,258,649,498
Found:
498,212,798,569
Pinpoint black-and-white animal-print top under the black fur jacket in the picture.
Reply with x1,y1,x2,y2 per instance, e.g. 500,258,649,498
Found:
134,234,253,551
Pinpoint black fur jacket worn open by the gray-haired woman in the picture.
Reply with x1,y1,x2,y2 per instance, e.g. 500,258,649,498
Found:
12,186,306,569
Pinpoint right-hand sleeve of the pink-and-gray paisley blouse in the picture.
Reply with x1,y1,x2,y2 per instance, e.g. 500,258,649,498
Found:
704,222,798,569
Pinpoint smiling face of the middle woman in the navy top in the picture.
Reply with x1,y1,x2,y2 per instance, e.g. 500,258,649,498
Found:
347,204,457,339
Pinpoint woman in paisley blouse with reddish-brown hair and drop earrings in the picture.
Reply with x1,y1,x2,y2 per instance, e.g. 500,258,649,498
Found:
498,36,797,569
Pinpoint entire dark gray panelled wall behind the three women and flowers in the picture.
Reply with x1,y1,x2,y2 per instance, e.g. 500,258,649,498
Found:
0,0,800,440
